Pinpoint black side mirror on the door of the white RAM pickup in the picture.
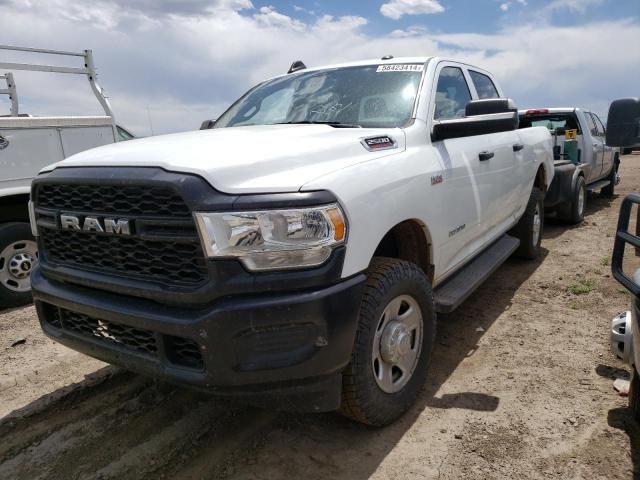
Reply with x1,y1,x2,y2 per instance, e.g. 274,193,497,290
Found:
431,98,519,142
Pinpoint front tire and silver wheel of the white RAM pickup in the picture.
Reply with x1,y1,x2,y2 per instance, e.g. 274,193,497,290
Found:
340,257,436,427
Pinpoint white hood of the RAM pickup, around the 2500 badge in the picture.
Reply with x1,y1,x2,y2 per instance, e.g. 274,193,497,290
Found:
52,125,405,194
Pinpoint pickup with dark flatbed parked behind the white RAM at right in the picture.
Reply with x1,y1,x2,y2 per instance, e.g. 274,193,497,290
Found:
520,107,620,224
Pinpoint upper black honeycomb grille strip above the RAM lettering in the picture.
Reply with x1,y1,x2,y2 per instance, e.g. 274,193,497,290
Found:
36,184,191,217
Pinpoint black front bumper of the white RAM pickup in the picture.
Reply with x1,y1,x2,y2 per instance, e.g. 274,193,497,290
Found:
31,269,365,411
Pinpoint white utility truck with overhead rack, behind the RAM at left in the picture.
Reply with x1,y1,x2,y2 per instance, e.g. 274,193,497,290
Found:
0,45,132,308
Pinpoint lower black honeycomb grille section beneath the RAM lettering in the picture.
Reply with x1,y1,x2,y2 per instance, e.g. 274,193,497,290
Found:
40,228,208,286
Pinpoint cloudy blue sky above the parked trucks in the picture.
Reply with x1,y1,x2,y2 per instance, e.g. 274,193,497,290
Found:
0,0,640,135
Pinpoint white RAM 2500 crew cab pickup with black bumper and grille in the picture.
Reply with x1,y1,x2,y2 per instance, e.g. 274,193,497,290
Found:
31,57,553,425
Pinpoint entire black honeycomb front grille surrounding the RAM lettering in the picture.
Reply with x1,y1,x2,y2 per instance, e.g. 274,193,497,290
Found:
34,183,209,289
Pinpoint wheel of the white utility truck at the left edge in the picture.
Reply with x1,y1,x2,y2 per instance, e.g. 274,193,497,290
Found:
0,223,38,307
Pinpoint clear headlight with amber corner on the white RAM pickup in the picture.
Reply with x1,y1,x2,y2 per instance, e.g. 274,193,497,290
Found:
195,204,347,271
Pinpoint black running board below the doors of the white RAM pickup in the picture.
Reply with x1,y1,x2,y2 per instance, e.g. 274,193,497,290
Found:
434,235,520,313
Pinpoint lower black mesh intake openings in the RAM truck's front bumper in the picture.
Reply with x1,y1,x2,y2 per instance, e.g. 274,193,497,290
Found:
41,304,204,370
